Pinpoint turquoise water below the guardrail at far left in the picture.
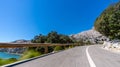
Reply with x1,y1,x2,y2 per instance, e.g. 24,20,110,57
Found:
0,52,20,59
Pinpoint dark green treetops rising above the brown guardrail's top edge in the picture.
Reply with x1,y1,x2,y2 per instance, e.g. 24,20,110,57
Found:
31,31,73,43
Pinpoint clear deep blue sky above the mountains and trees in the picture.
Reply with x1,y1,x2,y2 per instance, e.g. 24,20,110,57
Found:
0,0,118,42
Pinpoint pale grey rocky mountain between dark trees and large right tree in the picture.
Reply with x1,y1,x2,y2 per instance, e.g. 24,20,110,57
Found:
70,28,109,44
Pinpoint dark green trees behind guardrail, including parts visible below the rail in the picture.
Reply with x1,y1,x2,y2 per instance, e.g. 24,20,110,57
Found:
28,31,73,54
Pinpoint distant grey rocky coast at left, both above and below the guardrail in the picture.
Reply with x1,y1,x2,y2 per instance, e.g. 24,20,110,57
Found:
0,39,31,54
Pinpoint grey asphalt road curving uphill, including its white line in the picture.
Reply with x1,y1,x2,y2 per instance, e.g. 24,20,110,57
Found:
9,45,120,67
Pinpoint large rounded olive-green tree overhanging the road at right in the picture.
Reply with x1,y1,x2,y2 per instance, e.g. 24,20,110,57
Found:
94,2,120,39
